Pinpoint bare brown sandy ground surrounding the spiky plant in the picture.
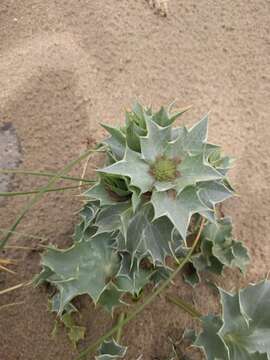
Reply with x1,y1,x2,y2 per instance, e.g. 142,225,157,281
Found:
0,0,270,360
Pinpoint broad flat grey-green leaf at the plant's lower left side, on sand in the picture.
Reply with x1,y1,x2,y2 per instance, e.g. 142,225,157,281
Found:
42,234,119,313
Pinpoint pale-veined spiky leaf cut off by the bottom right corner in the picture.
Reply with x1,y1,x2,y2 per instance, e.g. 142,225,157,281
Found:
195,280,270,360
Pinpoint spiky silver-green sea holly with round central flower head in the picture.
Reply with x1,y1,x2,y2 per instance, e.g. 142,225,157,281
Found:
28,103,260,359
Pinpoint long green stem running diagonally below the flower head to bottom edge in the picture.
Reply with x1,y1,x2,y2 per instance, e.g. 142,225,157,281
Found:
75,219,205,360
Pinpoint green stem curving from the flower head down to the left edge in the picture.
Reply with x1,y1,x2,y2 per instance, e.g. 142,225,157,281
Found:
0,149,101,250
